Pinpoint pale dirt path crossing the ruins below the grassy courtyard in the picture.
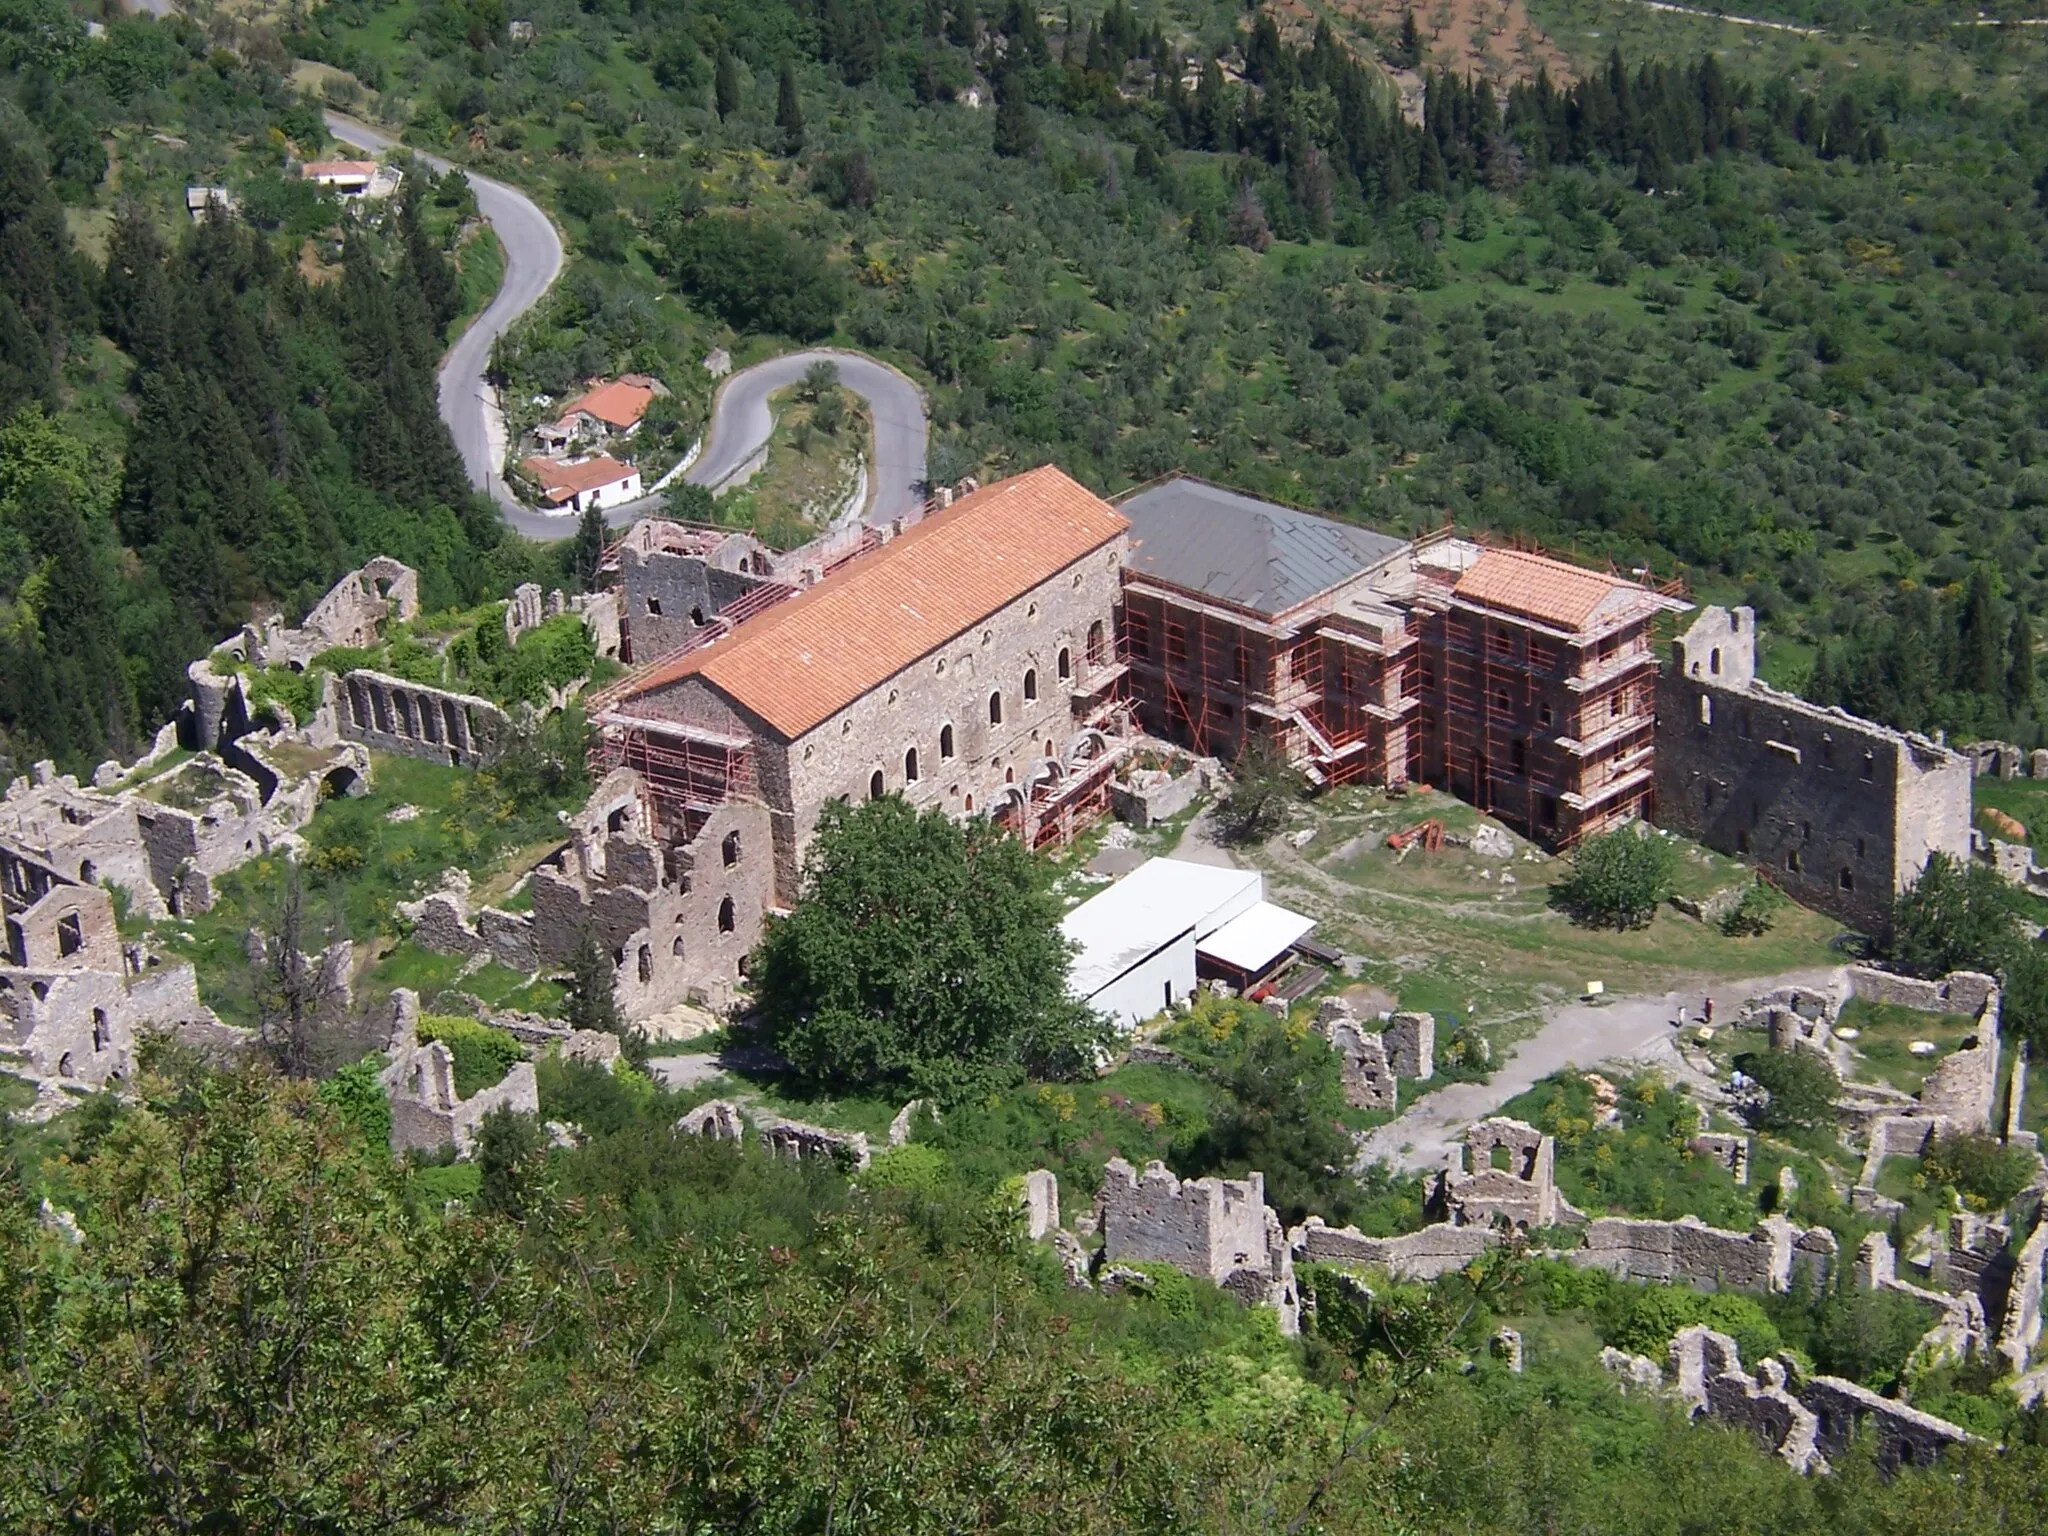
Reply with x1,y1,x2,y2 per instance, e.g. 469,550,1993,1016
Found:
1360,971,1837,1169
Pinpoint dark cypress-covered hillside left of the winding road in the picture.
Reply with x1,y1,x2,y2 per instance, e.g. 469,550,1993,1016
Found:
0,4,540,776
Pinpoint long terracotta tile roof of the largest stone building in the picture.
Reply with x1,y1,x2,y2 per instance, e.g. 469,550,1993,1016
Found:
621,467,1130,739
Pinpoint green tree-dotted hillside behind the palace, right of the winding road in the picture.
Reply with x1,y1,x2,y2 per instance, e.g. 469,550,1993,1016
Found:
291,0,2048,739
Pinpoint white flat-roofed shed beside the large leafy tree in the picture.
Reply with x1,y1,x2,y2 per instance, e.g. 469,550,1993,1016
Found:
1061,858,1315,1030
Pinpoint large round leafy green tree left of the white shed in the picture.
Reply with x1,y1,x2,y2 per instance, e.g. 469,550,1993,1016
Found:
754,797,1104,1100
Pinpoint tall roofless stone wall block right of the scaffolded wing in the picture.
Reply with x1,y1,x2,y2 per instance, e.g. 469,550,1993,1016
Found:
1657,608,1970,932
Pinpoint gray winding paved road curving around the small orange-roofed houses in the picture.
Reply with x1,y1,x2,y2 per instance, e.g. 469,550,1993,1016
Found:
328,113,928,539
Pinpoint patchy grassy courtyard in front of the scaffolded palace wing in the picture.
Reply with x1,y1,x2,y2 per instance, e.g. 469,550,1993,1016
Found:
1251,788,1841,1047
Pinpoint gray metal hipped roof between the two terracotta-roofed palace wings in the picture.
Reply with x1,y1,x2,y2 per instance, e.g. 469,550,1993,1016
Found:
1116,479,1405,614
